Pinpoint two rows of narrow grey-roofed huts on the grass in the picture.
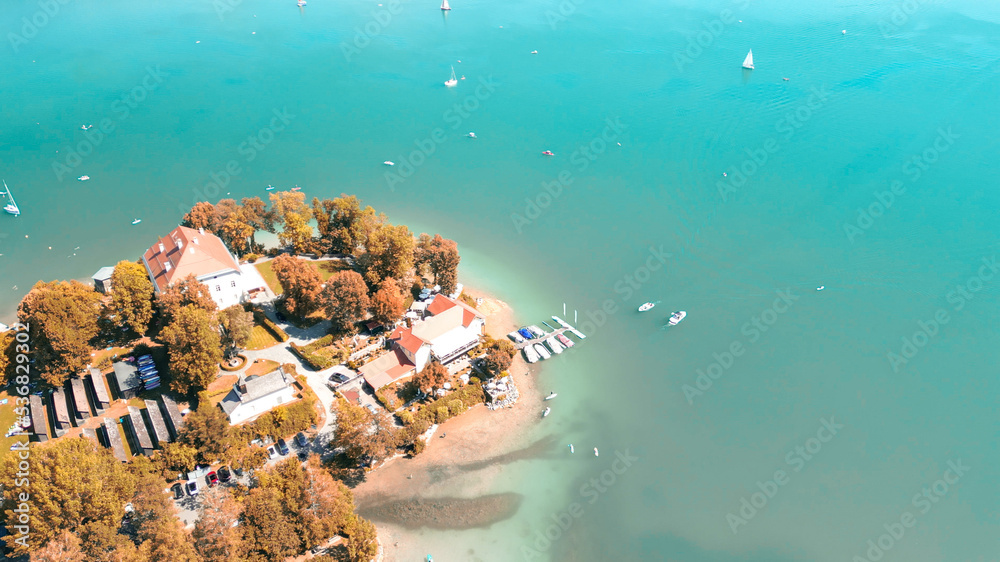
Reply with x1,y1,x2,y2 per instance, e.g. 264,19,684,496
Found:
28,369,183,462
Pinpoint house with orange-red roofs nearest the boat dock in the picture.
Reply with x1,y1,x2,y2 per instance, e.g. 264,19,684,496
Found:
359,295,486,390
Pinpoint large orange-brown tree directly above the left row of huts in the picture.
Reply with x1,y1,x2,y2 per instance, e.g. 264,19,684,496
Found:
17,281,101,385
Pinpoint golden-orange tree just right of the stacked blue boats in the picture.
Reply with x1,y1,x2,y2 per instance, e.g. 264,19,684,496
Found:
160,304,222,394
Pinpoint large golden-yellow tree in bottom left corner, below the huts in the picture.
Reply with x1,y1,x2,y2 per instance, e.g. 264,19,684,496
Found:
0,438,136,555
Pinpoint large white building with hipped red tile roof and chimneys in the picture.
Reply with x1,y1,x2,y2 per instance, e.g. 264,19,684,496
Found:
142,226,247,309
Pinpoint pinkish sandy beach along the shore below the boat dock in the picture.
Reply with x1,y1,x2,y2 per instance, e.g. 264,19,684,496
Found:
354,290,551,560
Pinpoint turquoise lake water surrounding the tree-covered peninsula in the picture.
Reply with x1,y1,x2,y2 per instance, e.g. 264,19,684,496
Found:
0,0,1000,562
